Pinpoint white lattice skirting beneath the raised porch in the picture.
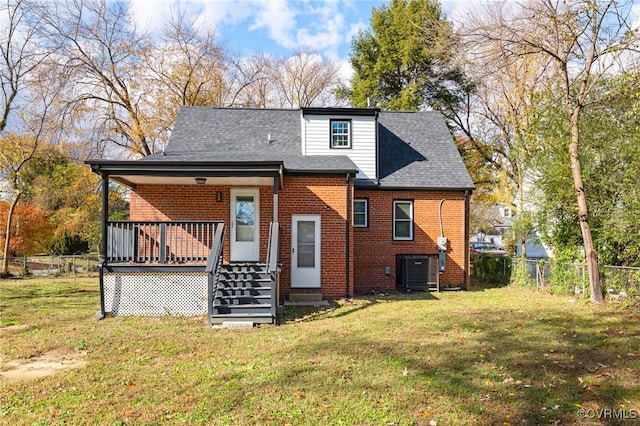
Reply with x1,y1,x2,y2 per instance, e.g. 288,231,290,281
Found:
104,272,207,316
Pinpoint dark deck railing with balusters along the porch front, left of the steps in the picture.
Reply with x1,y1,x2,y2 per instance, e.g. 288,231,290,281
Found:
106,221,222,264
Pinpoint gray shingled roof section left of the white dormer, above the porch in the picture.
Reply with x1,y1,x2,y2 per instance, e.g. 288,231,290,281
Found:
142,107,357,172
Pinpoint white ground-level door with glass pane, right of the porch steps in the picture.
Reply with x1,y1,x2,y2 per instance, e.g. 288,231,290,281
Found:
291,215,320,288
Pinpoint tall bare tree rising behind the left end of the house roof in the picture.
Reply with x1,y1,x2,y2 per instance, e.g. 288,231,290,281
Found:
37,0,159,156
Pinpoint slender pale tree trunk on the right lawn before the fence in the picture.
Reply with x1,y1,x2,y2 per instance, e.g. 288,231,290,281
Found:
569,107,604,303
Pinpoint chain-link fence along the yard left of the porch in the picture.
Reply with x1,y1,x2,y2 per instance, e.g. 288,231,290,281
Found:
0,253,101,277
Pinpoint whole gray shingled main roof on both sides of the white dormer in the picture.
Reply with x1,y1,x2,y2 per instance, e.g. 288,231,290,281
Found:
148,107,473,189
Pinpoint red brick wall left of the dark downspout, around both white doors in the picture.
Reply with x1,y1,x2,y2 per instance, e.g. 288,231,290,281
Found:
130,176,354,300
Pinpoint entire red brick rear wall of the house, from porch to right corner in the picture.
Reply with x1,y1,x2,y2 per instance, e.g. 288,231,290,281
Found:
130,181,469,300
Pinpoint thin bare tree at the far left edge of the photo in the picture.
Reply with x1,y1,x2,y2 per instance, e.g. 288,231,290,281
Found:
0,0,60,275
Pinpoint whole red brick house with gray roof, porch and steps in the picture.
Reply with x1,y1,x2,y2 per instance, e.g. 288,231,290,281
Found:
87,107,473,323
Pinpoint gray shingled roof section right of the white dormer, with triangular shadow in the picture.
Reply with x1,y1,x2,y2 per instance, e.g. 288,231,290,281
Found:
378,111,474,189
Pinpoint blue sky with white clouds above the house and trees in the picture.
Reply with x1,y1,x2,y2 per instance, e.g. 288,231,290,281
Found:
131,0,473,74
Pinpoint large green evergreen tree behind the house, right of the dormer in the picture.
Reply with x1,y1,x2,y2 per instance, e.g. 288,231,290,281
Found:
346,0,468,115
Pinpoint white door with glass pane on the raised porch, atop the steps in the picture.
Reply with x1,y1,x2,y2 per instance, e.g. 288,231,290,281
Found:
230,188,260,262
